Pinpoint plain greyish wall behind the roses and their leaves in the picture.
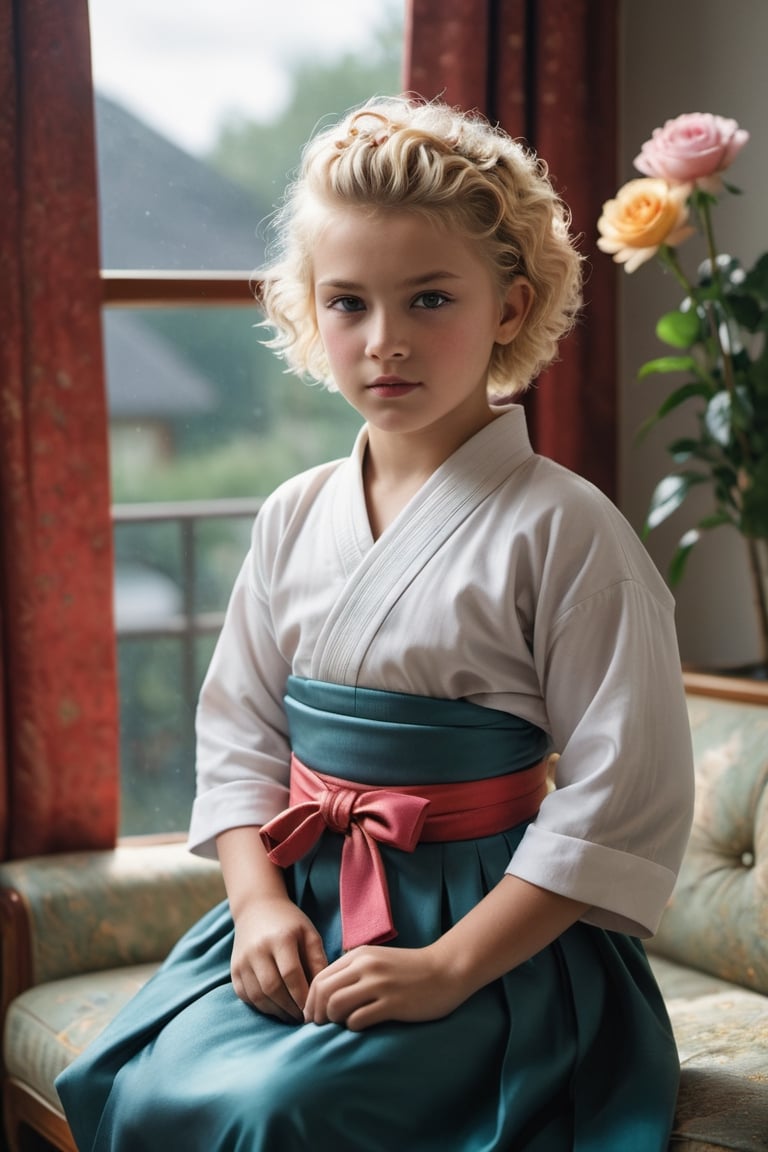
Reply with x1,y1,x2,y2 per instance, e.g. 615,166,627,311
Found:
606,0,768,667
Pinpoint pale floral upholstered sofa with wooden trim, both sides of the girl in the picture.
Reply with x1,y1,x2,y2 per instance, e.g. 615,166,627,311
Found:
0,674,768,1152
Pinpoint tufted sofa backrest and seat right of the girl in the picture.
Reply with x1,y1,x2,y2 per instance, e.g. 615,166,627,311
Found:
648,673,768,1152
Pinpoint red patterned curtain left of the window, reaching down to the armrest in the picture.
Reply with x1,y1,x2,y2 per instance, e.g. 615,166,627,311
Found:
0,0,119,858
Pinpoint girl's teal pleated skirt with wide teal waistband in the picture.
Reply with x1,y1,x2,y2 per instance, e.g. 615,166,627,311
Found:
56,679,679,1152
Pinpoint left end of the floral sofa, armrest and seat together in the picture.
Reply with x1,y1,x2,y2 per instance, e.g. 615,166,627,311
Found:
0,843,225,1150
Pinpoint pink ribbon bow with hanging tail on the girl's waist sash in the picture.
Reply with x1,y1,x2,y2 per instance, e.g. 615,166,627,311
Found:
261,756,429,950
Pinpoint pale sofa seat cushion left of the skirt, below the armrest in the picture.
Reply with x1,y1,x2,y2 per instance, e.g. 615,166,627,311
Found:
3,964,158,1108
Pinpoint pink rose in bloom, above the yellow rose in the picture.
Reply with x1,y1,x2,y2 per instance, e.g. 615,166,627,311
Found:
634,112,750,192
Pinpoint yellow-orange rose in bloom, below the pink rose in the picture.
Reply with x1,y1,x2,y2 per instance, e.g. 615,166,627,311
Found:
598,177,695,272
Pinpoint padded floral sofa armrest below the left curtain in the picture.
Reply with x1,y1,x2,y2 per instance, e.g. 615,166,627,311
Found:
0,842,225,1003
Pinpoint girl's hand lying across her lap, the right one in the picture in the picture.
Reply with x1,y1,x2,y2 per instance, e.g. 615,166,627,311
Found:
304,945,466,1032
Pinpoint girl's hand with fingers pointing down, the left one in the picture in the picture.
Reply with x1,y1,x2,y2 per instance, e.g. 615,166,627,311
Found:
231,896,328,1023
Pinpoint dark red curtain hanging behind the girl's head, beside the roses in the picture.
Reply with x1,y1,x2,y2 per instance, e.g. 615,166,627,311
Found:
404,0,618,498
